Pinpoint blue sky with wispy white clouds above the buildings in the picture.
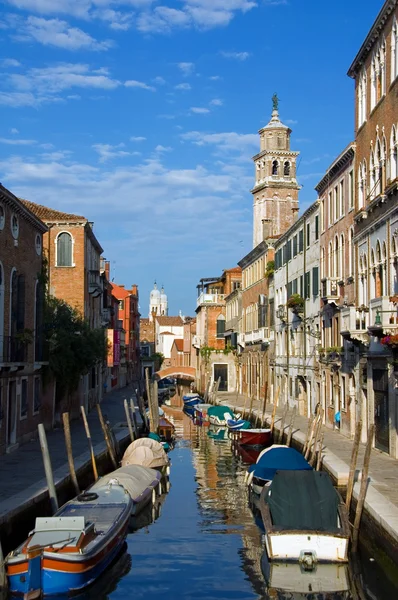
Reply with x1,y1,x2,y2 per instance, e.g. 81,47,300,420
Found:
0,0,383,316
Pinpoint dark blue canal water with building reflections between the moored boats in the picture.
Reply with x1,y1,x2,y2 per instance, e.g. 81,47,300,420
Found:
71,409,398,600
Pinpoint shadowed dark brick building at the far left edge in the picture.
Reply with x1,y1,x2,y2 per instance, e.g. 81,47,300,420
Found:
0,185,49,455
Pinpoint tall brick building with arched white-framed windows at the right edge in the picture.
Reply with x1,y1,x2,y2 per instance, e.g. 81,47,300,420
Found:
348,0,398,457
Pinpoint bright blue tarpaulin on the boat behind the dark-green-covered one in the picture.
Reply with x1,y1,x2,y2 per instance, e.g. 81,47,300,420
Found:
248,446,312,481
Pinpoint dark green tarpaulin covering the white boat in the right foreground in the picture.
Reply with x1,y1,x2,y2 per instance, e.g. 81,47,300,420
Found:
265,471,340,533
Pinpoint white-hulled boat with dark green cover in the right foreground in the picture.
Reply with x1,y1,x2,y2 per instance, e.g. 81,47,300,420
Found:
260,470,350,570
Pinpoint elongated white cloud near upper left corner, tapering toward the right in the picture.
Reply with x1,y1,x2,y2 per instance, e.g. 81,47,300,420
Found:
13,16,112,50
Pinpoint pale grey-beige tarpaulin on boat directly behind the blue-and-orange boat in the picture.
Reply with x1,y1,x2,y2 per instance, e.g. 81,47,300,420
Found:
90,465,161,501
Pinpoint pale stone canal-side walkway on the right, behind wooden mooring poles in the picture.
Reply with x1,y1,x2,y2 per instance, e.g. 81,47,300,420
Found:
217,394,398,573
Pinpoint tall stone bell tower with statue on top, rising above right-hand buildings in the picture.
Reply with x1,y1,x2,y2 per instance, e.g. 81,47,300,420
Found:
251,94,300,248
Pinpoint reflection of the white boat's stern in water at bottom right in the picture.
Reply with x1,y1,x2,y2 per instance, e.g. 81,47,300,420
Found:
261,551,352,600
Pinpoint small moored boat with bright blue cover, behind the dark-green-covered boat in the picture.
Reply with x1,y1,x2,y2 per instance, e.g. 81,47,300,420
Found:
247,444,312,494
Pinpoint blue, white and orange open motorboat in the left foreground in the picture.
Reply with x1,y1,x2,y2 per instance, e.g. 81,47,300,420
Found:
6,482,133,600
